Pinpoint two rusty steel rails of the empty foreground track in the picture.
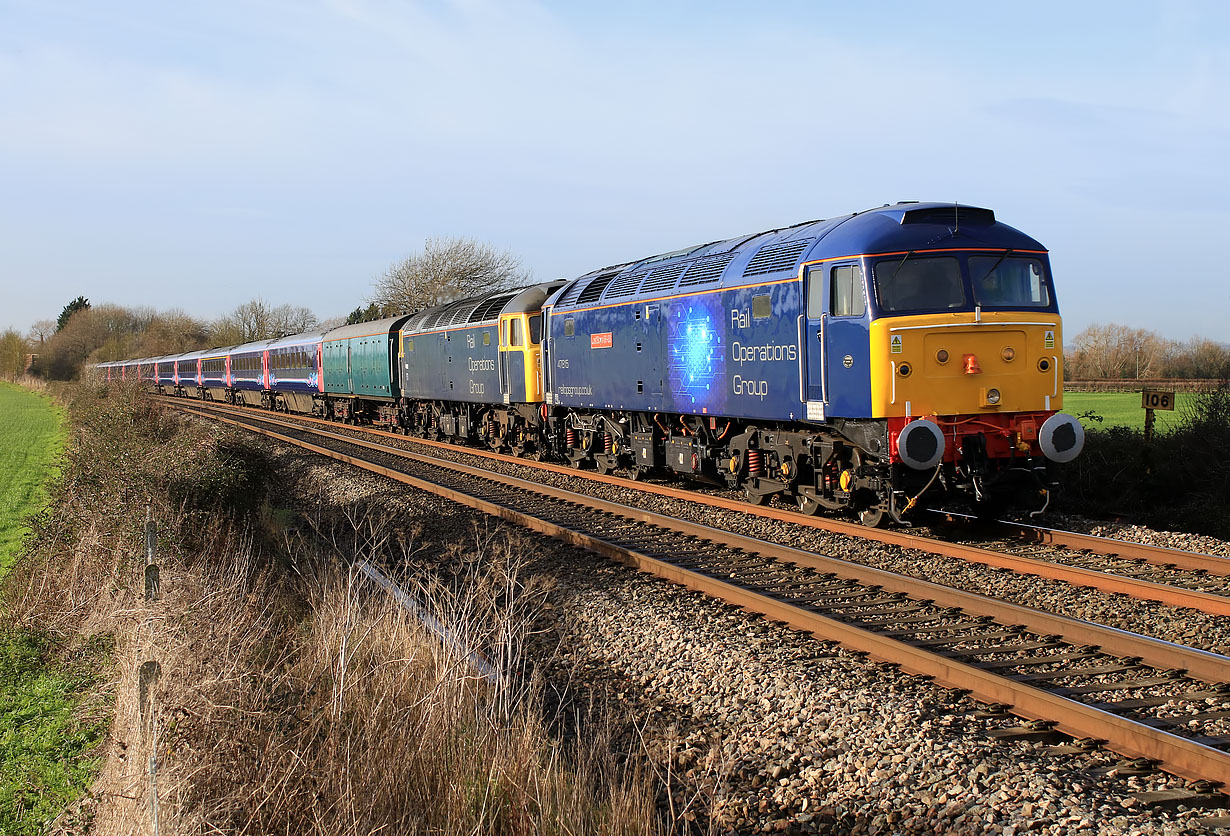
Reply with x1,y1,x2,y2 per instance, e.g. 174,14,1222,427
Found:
168,406,1230,792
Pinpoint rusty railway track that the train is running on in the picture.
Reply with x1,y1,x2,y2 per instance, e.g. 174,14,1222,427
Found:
153,398,1230,616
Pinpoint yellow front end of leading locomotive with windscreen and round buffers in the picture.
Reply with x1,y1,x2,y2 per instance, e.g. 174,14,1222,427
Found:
868,244,1084,514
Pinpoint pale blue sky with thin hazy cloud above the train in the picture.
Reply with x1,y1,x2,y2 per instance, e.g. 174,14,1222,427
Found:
0,0,1230,342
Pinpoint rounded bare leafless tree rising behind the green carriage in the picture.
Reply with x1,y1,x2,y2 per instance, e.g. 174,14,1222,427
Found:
370,239,529,316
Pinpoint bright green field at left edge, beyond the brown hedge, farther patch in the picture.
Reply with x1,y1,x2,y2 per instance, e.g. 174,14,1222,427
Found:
0,384,64,577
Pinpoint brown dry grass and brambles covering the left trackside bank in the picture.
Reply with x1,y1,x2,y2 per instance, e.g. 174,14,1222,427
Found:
6,381,688,836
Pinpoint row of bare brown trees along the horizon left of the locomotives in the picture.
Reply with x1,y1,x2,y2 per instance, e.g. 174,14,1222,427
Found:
0,239,530,380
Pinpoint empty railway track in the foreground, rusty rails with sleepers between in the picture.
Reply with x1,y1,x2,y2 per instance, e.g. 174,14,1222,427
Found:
166,403,1230,791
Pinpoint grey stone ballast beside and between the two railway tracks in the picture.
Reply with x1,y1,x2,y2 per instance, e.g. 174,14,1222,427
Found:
234,418,1226,835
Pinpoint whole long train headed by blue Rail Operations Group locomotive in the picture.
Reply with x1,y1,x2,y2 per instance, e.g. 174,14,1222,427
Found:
100,203,1084,525
